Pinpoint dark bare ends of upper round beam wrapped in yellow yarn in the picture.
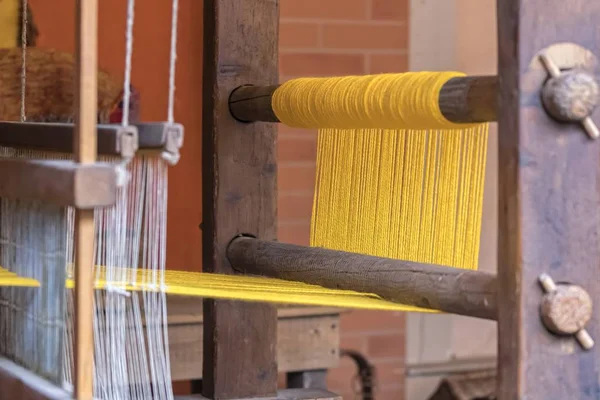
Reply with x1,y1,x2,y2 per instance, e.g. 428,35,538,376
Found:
229,76,498,123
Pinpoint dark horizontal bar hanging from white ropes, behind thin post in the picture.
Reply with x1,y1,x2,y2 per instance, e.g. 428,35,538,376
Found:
0,122,183,159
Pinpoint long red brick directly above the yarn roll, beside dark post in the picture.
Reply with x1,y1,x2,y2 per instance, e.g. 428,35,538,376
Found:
279,52,365,76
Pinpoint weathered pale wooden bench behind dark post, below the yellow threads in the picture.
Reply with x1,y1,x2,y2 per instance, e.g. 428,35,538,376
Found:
162,296,342,381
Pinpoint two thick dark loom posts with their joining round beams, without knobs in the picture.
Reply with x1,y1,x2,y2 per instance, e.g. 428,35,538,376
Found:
203,0,600,400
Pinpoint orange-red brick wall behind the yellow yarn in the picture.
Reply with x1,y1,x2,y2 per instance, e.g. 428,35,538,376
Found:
279,0,408,400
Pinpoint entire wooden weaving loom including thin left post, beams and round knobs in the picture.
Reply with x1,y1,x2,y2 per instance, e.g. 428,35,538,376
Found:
0,0,600,400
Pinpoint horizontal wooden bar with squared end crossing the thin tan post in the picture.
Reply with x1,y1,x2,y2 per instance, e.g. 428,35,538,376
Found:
0,159,118,209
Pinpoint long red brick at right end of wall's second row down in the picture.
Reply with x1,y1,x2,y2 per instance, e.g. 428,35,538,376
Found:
323,23,408,50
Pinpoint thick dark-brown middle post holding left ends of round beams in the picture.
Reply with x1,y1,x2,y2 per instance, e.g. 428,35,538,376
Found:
202,0,279,399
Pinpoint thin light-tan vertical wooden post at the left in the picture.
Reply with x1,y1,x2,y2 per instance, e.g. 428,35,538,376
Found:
73,0,98,400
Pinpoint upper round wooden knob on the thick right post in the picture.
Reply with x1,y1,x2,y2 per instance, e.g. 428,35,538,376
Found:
542,70,600,122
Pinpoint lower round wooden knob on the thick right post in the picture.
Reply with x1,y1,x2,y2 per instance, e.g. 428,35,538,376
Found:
541,285,592,335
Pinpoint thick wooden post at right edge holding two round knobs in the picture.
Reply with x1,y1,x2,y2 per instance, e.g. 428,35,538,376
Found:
498,0,600,400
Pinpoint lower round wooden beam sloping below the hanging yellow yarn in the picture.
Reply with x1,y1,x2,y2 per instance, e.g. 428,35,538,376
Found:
227,237,497,320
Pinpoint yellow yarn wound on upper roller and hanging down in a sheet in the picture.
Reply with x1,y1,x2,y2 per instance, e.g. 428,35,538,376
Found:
272,72,488,302
